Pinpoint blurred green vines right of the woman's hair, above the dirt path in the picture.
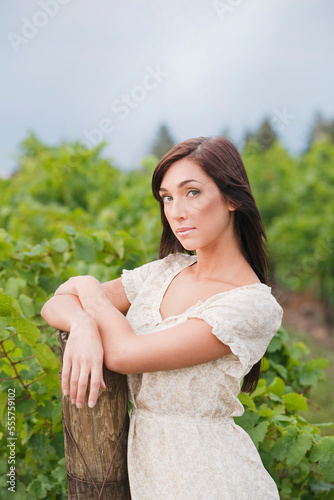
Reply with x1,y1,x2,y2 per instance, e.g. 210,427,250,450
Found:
243,140,334,307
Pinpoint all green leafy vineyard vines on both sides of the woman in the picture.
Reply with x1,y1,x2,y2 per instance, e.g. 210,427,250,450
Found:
0,135,334,500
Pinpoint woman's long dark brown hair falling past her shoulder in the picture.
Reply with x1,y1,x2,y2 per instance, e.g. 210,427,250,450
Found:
152,137,269,393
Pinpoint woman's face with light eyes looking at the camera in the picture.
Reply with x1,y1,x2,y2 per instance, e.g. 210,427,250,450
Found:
159,158,235,250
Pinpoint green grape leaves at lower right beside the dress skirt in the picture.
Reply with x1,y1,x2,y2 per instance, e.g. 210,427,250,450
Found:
235,328,334,500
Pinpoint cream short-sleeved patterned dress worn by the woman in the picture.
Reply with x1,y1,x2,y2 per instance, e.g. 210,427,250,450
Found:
122,253,283,500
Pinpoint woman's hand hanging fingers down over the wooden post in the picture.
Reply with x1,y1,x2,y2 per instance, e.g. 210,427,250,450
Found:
61,314,106,408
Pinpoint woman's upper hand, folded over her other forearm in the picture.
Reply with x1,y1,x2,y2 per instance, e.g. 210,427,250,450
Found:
54,276,109,318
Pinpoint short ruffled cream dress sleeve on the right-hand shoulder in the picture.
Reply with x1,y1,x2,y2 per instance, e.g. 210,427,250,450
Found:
188,289,283,379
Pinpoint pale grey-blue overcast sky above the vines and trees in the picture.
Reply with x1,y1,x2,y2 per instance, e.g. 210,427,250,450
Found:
0,0,334,176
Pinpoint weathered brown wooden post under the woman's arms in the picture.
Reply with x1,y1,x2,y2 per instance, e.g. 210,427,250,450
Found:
57,330,131,500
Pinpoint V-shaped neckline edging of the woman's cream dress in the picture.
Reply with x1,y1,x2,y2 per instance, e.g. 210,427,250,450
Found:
154,254,271,326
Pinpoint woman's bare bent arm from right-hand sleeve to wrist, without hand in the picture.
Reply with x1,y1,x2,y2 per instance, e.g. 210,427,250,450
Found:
91,303,231,374
